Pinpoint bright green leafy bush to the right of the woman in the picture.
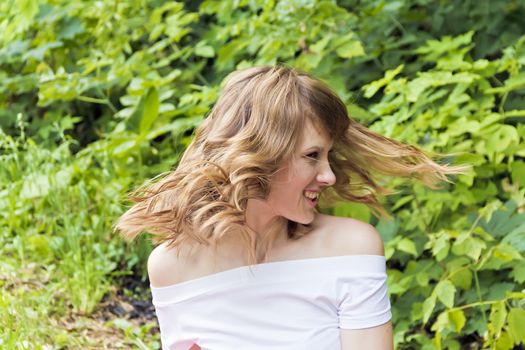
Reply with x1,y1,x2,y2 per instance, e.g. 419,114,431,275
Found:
363,28,525,348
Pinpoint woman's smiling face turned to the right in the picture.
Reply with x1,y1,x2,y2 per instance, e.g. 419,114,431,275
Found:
267,122,335,224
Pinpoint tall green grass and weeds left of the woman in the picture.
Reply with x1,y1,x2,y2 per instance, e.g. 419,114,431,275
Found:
0,128,160,350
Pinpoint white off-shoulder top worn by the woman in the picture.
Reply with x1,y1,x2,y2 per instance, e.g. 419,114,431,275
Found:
151,255,391,350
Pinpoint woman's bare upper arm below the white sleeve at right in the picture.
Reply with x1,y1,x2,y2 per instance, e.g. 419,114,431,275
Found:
341,321,394,350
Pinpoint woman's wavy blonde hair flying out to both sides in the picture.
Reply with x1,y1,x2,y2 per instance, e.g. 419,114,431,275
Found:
116,66,462,257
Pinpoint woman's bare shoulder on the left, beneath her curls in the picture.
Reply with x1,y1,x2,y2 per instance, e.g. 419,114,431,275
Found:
148,243,202,287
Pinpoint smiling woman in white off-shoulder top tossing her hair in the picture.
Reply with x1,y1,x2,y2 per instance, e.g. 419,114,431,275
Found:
117,67,460,350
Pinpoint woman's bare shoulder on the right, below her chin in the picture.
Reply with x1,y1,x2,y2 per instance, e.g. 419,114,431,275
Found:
317,215,385,256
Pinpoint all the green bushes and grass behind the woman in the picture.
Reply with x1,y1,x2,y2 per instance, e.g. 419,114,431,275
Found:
0,0,525,349
